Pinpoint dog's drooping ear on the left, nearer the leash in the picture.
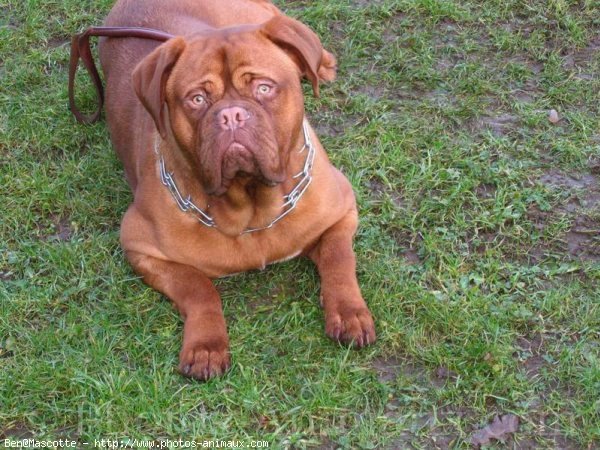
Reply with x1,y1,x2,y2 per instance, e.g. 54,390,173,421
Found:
132,37,186,138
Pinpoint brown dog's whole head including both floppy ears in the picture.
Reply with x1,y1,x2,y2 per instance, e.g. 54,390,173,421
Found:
133,16,335,195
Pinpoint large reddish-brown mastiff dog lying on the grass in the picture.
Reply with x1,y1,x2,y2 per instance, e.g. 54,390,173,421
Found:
100,0,375,379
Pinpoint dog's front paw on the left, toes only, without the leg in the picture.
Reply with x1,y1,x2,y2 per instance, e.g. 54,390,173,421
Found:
179,337,231,381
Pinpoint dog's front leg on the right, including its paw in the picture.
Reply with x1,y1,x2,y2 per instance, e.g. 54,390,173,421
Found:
309,210,375,348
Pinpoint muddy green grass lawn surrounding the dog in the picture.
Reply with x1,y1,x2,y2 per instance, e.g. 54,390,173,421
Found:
0,0,600,449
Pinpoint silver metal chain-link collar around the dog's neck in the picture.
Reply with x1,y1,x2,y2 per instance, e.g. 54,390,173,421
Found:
154,119,316,235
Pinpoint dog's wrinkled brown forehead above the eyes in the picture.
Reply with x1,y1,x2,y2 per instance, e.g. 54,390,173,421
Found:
171,27,299,93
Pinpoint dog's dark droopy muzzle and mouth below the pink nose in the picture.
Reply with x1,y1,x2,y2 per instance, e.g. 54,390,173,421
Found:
199,121,285,196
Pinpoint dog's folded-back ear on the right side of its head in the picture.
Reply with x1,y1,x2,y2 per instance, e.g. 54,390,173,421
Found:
261,14,337,97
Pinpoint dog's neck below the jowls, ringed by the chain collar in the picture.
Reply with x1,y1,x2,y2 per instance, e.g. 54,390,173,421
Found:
155,124,315,236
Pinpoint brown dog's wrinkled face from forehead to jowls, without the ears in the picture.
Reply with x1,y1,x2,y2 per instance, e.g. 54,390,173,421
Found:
166,32,303,195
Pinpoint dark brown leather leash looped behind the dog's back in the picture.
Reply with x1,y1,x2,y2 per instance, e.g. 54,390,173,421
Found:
69,27,174,124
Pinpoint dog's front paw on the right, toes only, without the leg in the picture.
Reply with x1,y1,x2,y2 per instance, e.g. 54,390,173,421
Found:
325,305,376,348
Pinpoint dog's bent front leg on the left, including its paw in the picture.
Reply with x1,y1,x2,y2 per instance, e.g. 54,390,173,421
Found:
126,251,230,380
